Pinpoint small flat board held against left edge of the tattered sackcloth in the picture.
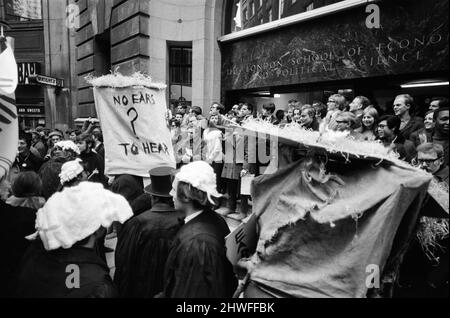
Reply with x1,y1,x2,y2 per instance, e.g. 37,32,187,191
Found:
225,214,258,265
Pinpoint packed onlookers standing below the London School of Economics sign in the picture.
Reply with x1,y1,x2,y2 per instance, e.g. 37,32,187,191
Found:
170,94,449,218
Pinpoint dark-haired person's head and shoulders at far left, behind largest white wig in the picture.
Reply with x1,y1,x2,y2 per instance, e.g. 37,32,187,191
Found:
6,171,45,210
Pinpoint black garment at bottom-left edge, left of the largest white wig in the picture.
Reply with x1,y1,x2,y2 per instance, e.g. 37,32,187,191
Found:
0,200,36,298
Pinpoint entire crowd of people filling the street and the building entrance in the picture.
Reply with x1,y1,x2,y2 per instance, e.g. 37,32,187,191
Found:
0,94,449,298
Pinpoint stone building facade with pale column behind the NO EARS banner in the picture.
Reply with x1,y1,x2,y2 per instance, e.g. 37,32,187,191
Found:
73,0,224,117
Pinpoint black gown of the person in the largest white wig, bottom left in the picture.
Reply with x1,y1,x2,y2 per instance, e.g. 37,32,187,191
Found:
14,240,117,298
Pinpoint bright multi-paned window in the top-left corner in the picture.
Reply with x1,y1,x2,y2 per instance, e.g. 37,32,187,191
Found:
2,0,42,21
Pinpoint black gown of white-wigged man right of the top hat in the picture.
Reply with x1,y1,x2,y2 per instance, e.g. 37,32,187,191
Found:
164,210,237,298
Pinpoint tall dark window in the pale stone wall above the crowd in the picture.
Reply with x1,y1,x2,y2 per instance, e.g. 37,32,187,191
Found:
169,46,192,105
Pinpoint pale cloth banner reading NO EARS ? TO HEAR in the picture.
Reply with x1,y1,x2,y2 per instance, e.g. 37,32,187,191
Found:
91,75,175,177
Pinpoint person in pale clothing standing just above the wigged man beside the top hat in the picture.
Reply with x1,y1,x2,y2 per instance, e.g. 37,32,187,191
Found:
203,114,223,194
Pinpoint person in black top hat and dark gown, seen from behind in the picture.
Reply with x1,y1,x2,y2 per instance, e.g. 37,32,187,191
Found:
114,167,184,297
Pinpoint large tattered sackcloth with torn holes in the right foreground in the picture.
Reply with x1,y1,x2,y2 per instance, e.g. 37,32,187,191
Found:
239,121,431,298
